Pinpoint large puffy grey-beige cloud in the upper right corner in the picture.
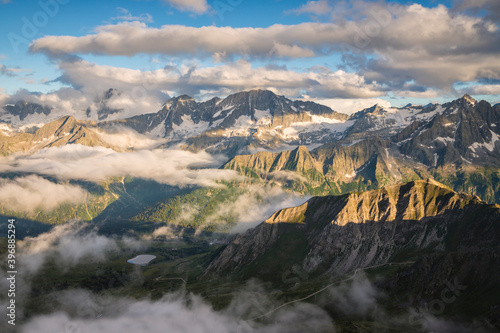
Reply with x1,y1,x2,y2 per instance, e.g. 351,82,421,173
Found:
346,4,500,91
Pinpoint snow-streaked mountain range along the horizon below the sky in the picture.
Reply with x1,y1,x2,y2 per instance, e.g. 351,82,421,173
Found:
0,89,500,161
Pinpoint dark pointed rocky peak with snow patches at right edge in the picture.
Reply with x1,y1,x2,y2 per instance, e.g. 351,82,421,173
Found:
392,96,500,167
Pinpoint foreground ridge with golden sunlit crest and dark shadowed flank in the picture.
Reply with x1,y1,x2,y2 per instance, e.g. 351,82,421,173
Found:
207,181,500,278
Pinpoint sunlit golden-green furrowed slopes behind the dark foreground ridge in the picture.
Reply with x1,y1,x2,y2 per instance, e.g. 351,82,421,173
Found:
223,138,401,195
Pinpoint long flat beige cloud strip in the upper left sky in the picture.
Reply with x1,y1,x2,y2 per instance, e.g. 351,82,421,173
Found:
31,22,346,57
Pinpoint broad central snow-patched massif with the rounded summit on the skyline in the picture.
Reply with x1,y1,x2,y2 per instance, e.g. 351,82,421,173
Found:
110,90,348,140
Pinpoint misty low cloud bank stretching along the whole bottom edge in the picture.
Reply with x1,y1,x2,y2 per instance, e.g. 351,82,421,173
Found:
15,274,476,333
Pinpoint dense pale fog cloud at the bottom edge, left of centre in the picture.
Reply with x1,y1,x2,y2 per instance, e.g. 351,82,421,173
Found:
23,287,334,333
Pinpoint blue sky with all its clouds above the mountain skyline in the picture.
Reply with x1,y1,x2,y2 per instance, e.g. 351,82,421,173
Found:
0,0,500,112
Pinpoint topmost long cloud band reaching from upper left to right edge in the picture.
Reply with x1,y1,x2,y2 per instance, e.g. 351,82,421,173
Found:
31,4,498,63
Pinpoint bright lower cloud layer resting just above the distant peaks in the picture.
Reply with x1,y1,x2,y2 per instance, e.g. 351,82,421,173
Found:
0,57,386,118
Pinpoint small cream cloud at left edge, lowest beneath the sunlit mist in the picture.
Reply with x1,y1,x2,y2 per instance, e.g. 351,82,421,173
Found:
0,175,88,212
